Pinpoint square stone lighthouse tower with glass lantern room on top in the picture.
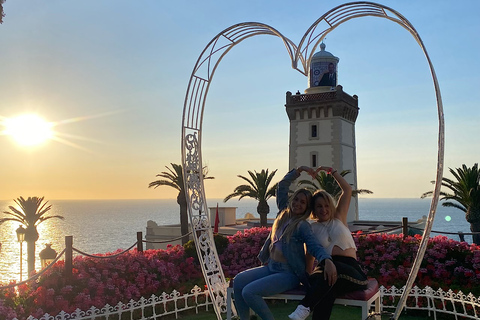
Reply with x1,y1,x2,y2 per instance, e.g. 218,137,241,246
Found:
285,43,359,222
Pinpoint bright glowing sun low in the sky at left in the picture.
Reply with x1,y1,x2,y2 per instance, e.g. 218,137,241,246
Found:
3,114,53,147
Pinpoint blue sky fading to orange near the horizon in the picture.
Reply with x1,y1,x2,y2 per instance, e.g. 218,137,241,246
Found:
0,0,480,200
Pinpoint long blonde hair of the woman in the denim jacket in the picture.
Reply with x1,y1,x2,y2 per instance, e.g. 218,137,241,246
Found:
271,189,312,242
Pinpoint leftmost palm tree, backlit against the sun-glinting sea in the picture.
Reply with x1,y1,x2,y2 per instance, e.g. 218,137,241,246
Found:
0,197,64,275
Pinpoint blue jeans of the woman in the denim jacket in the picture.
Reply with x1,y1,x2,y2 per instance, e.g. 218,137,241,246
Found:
233,260,300,320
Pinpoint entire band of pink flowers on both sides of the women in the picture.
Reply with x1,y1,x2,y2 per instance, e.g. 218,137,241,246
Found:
0,228,480,320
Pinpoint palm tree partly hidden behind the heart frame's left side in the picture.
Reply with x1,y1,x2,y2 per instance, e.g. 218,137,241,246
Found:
148,163,214,244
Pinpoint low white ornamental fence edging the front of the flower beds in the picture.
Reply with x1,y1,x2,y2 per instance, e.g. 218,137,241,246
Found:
18,286,480,320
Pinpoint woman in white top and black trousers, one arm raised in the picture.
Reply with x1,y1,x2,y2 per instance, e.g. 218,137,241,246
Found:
289,166,368,320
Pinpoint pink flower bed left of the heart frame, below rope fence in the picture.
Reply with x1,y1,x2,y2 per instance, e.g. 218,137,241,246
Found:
0,246,204,320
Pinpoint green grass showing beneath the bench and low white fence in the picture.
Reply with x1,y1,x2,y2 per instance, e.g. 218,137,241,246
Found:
172,300,433,320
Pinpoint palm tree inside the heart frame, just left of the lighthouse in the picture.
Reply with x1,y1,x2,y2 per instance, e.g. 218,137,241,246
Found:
223,169,277,227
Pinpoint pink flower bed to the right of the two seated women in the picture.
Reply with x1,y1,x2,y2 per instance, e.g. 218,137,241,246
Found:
355,234,480,295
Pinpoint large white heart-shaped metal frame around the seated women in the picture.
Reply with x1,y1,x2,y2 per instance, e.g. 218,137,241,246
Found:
182,1,444,320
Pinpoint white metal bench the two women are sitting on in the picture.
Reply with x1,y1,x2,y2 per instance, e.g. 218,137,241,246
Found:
227,279,382,320
